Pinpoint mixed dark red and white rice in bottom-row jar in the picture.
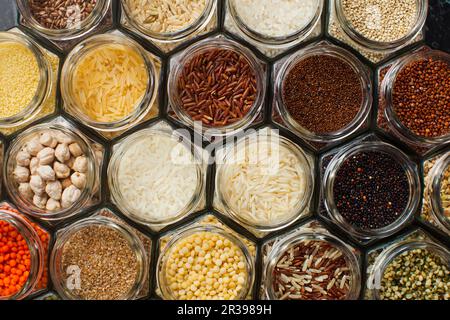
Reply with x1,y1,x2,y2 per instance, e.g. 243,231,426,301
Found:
272,240,351,300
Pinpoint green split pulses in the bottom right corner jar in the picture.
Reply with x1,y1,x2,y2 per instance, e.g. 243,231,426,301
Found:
380,249,450,300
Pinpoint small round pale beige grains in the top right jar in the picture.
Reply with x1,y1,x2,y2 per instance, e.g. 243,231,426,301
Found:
341,0,418,42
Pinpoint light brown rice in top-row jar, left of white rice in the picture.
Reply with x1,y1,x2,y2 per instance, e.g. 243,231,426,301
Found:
124,0,209,33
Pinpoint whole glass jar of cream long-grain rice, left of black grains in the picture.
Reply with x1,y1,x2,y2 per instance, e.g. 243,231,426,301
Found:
216,134,314,234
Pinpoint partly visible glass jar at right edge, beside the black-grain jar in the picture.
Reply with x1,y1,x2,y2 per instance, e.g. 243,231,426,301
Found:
421,151,450,235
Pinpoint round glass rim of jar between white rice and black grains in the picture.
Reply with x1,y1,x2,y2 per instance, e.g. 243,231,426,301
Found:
215,135,314,232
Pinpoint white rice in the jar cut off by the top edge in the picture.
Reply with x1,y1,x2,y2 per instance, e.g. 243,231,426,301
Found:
232,0,319,37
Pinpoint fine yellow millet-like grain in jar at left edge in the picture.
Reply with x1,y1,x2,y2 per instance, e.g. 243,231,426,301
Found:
0,42,40,119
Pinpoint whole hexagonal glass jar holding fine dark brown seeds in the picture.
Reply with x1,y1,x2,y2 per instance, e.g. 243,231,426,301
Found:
273,42,373,148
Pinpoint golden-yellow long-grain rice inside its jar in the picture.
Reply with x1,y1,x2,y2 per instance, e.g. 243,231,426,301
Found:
73,44,149,123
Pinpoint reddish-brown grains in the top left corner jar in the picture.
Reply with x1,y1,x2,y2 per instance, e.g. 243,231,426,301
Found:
29,0,97,29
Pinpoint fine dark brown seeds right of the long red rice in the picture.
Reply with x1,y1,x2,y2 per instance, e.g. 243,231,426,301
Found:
281,55,363,134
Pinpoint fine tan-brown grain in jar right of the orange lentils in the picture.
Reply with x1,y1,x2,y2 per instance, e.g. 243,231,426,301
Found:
61,225,139,300
